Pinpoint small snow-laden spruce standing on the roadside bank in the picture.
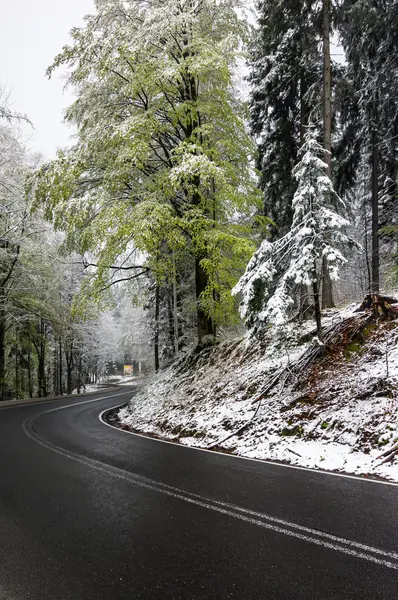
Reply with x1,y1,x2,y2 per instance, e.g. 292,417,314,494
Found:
233,129,350,343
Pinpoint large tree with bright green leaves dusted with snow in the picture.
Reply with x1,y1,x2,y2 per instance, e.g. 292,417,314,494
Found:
32,0,258,341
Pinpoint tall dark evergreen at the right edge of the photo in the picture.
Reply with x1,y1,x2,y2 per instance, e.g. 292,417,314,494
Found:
338,0,398,292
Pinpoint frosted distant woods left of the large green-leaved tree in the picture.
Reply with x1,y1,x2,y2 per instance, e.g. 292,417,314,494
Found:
0,92,152,400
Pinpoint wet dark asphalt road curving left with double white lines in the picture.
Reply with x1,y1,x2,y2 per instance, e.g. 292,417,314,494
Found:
0,388,398,600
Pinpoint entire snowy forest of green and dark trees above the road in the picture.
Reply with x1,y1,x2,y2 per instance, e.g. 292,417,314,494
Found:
0,0,398,399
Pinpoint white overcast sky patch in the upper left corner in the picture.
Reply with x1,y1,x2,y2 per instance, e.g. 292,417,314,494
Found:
0,0,94,158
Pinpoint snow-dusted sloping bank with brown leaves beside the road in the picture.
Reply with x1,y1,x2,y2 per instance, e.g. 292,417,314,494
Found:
118,305,398,481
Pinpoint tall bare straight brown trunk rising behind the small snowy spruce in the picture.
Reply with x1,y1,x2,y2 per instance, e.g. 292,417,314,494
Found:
322,0,334,308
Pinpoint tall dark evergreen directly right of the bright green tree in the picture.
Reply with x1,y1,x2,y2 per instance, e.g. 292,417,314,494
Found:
249,0,322,237
